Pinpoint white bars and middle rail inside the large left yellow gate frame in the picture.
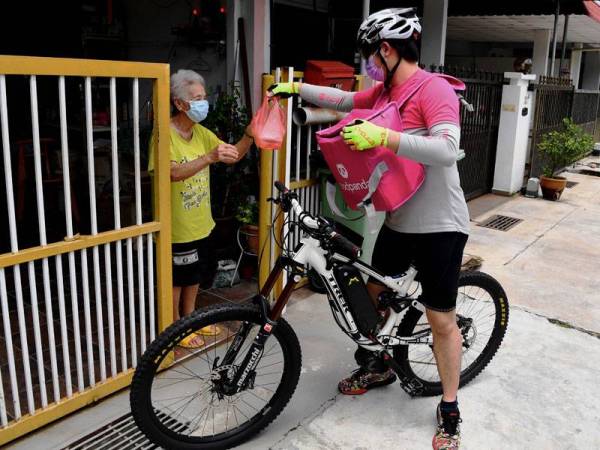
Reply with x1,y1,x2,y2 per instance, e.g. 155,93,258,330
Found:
0,57,168,444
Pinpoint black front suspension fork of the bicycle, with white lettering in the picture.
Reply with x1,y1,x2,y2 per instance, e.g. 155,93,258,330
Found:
226,257,299,395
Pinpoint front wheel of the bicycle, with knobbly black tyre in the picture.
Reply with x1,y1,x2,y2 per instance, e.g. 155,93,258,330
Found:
130,304,301,450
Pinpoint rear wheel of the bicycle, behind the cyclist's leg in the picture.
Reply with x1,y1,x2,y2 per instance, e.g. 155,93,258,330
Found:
394,272,508,396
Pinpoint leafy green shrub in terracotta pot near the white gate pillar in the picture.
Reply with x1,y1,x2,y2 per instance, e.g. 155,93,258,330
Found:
538,118,594,200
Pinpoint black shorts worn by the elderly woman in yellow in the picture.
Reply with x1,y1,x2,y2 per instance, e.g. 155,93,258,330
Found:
172,236,217,289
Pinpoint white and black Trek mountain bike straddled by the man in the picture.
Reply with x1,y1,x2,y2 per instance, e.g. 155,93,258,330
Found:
130,182,509,450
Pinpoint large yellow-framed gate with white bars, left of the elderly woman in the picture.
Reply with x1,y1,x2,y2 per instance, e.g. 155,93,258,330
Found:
0,56,172,445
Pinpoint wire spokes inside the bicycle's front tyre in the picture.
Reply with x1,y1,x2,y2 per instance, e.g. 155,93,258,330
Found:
143,312,285,442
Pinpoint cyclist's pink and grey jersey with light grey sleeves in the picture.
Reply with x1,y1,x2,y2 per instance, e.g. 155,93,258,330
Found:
300,69,469,234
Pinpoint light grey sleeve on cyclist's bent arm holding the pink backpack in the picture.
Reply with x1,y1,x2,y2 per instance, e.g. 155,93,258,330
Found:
396,123,460,167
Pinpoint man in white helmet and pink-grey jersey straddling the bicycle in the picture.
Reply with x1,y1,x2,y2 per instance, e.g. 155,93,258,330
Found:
271,8,469,450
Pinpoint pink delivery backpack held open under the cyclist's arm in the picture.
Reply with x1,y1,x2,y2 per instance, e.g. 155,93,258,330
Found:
316,74,464,221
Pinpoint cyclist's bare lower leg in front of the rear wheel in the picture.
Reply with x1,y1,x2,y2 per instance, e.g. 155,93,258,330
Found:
426,309,462,402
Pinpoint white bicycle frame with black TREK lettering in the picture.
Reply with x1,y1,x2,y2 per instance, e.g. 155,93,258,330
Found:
261,236,433,351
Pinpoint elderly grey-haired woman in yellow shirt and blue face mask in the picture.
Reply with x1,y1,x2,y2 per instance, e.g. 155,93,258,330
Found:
148,70,253,348
